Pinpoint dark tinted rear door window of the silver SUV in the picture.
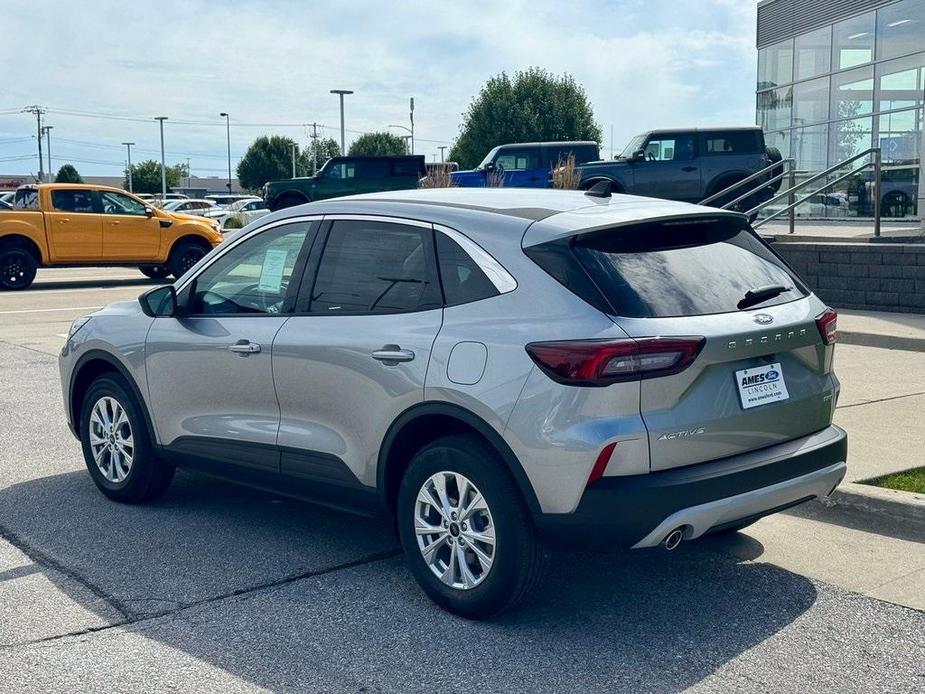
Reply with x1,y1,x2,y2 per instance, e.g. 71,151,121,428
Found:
299,221,442,315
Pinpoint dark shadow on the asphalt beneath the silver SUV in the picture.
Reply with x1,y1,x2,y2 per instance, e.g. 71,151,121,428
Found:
0,472,816,691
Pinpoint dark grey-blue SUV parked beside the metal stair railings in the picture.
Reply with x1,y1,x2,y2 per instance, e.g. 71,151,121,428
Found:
579,127,782,210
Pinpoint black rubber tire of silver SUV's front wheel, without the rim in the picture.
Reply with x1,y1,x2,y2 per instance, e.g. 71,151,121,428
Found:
79,377,162,502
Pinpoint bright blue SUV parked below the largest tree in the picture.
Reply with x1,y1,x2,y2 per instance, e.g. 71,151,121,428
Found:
450,142,601,188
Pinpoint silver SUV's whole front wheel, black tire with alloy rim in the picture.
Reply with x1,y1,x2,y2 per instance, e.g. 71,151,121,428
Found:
80,375,175,504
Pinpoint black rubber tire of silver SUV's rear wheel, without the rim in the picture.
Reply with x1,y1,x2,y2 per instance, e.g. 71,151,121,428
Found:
396,437,536,618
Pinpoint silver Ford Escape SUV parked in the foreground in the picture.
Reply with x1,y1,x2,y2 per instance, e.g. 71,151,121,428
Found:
60,188,847,617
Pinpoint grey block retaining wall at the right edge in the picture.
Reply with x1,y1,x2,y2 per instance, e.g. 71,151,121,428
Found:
773,242,925,313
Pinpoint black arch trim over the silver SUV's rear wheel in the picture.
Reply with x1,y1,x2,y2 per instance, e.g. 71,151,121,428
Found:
376,401,542,517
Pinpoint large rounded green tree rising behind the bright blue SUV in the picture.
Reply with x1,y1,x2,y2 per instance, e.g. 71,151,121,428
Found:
450,67,601,169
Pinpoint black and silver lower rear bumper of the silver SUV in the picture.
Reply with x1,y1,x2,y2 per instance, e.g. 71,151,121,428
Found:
536,426,848,549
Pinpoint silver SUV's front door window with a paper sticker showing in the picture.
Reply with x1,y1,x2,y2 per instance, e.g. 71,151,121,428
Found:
186,222,311,315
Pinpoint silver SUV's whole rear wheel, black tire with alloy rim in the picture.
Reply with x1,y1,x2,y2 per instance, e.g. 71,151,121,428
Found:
397,435,547,619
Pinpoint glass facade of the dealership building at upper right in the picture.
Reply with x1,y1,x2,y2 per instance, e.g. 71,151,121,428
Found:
757,0,925,217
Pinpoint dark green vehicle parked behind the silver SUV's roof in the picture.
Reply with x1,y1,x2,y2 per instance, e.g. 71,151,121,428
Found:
263,155,426,211
